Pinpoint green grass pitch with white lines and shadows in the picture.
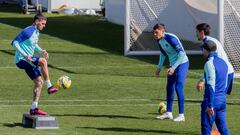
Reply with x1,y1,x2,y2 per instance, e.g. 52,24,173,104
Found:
0,6,240,135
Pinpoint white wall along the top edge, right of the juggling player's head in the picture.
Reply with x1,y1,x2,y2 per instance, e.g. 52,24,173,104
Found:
32,0,101,10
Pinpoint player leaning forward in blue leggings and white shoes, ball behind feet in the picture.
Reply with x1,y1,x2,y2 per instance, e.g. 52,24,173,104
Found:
153,24,189,122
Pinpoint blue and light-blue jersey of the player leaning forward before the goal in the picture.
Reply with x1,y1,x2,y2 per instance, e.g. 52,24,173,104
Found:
157,33,188,70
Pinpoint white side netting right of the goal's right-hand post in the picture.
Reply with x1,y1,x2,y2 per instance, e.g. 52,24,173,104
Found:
224,0,240,77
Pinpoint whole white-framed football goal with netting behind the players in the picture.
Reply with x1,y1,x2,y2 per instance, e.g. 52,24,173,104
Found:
124,0,240,72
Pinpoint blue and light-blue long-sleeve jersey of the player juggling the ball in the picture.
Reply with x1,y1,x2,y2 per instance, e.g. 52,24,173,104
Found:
11,25,43,63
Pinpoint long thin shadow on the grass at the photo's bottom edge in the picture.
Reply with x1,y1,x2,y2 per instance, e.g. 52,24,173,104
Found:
77,127,200,135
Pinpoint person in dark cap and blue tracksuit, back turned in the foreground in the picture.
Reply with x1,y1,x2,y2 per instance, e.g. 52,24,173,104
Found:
201,40,229,135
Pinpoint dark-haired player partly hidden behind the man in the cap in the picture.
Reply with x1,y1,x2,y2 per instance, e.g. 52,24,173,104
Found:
196,23,234,95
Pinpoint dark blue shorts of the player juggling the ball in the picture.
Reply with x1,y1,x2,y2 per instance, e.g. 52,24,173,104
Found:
16,56,41,80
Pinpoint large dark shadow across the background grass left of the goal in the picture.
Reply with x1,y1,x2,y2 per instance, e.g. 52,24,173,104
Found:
0,4,204,69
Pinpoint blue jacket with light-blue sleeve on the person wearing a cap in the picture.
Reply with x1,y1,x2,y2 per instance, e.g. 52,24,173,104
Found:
203,53,228,108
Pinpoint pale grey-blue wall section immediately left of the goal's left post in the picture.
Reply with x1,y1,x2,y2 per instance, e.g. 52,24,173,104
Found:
105,0,125,25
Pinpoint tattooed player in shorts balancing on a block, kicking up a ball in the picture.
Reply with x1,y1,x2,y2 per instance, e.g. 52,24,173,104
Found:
11,14,58,115
